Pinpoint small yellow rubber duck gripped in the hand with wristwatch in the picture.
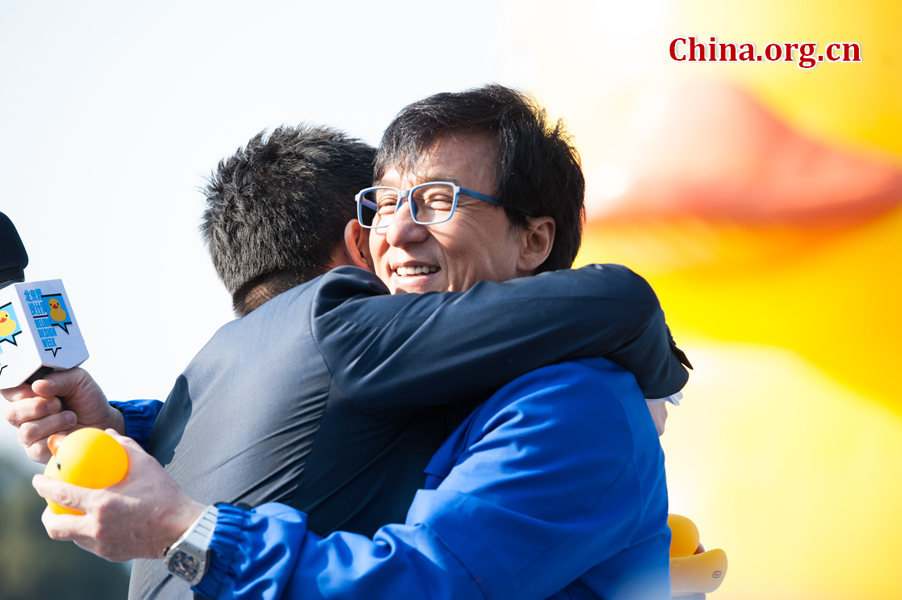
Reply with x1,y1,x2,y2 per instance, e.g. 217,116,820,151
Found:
44,427,128,515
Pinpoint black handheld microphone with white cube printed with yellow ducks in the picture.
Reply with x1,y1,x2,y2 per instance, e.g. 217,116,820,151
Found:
0,213,88,389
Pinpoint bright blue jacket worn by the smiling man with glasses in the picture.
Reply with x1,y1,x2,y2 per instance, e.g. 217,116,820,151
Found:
195,359,670,600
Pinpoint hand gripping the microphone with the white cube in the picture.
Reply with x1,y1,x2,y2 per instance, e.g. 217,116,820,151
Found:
2,369,125,463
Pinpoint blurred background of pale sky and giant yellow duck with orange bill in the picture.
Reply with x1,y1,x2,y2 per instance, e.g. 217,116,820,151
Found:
0,0,902,600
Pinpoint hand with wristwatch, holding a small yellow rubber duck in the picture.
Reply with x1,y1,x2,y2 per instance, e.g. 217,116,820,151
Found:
32,429,205,562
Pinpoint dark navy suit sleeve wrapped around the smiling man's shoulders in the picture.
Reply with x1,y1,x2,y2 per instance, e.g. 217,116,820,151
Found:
312,265,689,413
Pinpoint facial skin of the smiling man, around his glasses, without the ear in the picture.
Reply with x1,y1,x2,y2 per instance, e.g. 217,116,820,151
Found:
369,134,521,294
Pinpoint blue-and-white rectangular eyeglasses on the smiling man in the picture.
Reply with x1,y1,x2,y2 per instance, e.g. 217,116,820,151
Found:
354,181,525,229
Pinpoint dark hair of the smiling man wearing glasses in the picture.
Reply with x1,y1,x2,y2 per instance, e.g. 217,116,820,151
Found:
375,84,585,272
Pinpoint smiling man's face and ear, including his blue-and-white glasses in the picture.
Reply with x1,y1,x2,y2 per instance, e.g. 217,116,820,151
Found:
359,134,548,293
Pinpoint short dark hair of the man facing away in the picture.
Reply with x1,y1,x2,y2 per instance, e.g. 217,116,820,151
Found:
200,125,376,314
